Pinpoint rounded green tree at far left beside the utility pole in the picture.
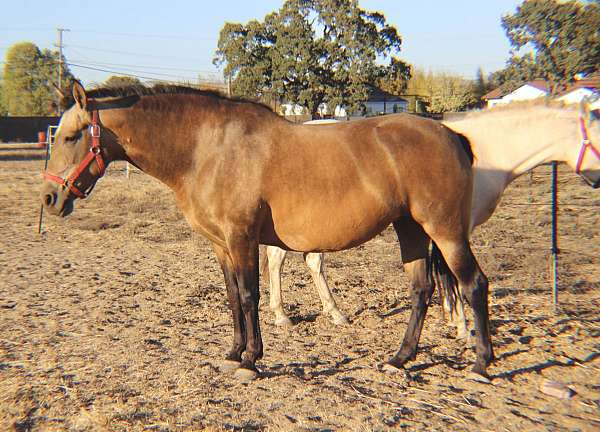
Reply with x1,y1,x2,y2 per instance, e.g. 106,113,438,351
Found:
3,42,72,116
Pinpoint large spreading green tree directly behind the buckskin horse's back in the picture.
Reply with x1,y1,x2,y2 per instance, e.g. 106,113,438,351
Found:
214,0,410,116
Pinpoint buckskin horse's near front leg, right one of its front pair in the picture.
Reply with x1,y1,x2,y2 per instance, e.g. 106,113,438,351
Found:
227,234,263,381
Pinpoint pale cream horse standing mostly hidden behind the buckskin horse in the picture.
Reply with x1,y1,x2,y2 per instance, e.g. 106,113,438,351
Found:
266,103,600,330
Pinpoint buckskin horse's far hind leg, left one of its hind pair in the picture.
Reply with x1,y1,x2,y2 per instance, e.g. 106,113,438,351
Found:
384,220,433,371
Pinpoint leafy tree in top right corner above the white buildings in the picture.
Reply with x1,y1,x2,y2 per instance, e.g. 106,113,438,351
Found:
496,0,600,93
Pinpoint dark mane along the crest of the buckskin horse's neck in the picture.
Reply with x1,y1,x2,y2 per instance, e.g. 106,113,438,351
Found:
61,84,273,112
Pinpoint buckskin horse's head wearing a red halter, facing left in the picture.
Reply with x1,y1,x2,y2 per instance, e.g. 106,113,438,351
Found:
41,81,135,217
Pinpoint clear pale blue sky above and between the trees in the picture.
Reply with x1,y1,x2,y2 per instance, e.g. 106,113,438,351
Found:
0,0,521,84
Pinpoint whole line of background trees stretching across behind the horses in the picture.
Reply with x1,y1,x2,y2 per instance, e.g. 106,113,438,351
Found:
0,0,600,115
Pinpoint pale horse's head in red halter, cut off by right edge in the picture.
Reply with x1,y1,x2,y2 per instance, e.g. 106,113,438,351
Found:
567,102,600,189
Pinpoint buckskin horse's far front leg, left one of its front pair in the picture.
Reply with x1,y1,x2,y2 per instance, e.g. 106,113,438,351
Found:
213,244,246,372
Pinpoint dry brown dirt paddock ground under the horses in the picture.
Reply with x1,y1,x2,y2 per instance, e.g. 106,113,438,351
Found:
0,145,600,431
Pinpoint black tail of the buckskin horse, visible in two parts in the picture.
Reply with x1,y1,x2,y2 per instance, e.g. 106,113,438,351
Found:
427,132,475,313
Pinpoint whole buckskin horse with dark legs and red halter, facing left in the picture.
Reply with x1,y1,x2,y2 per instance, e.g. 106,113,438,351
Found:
40,82,493,381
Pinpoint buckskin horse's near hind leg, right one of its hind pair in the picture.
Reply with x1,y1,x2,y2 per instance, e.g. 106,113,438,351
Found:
434,238,494,377
